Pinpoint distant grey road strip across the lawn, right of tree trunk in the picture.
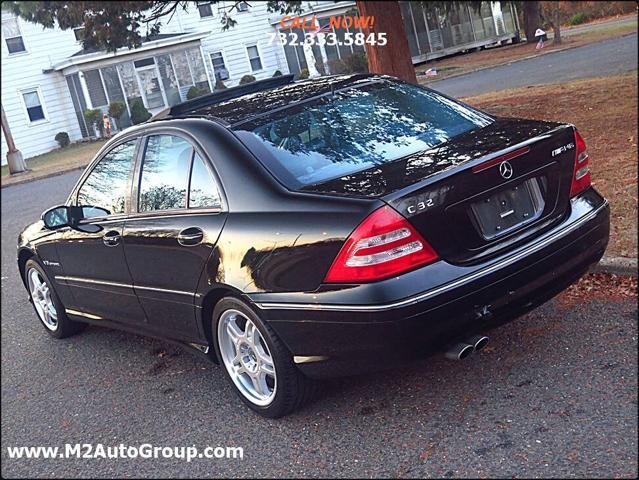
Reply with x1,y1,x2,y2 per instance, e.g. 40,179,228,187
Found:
427,34,637,97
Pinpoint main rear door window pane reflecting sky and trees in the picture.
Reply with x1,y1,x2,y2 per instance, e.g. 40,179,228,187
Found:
138,135,193,212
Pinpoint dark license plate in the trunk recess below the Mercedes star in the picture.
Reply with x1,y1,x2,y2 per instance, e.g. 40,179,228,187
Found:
470,178,544,239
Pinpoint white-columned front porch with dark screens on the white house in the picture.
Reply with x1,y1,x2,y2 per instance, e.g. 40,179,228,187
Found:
51,33,214,137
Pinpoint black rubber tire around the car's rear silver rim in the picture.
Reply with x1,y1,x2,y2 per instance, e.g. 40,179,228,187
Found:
211,297,315,418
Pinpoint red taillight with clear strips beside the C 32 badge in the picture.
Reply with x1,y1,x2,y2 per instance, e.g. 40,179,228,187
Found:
324,206,437,283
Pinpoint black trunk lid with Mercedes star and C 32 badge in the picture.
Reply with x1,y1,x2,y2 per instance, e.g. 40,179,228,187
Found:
305,118,574,264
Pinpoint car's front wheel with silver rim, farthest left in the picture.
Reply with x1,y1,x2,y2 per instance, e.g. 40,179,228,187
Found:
24,259,85,338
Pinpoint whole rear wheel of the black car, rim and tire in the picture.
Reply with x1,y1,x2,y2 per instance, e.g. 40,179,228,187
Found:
212,297,312,418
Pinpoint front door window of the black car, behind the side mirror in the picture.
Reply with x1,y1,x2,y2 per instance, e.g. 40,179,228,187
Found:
77,140,137,215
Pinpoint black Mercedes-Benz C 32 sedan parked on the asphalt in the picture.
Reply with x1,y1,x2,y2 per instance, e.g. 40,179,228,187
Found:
18,75,609,417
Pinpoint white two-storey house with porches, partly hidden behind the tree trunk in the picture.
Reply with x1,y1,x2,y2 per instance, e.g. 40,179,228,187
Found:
1,1,516,164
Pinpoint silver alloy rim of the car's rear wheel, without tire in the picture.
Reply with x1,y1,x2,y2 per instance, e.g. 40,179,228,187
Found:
217,309,277,407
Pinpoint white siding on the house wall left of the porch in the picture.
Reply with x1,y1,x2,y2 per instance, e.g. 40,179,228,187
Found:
2,13,82,165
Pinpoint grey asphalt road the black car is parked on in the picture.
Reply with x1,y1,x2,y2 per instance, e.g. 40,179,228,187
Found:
1,172,637,478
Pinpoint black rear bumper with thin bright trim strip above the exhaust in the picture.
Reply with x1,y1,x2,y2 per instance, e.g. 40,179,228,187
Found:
251,189,609,377
